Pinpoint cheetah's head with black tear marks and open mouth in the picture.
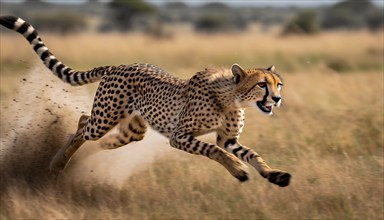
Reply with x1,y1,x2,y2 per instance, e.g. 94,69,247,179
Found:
231,64,283,115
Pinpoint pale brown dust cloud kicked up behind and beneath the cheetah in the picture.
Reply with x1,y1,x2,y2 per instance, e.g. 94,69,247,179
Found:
0,67,172,189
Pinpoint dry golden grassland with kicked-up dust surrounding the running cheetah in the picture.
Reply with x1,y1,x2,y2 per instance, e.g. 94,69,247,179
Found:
0,28,384,219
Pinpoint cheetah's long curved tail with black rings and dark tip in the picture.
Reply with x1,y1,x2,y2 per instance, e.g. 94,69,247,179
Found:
0,15,112,86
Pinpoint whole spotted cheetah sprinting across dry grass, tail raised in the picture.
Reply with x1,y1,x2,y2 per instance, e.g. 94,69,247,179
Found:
0,16,291,187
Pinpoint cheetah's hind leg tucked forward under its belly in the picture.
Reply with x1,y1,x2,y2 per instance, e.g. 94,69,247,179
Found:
100,115,147,149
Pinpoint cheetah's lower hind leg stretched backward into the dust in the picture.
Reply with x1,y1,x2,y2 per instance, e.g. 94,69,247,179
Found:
49,115,89,174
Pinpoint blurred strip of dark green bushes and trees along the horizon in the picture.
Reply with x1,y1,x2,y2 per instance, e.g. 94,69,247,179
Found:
0,0,383,34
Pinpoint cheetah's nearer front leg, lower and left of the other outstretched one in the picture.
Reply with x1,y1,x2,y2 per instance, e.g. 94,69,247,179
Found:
170,132,248,182
